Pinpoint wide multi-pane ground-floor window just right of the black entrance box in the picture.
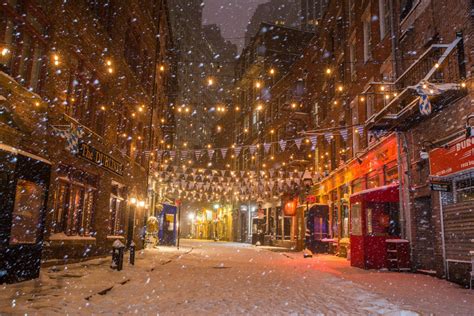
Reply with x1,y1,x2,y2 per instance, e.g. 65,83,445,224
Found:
53,166,97,236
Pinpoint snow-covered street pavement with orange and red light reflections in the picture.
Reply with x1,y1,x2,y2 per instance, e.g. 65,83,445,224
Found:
0,240,474,315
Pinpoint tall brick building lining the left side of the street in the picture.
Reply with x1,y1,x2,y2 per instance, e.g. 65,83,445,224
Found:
0,0,175,280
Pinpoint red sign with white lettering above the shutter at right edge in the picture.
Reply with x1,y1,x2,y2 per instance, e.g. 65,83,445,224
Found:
430,137,474,177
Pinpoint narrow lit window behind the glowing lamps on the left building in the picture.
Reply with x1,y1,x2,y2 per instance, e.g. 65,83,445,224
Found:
109,182,127,236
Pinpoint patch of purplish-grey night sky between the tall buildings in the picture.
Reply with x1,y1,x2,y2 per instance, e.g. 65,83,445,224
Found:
203,0,268,51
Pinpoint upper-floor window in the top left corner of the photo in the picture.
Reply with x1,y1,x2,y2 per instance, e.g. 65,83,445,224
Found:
0,1,47,92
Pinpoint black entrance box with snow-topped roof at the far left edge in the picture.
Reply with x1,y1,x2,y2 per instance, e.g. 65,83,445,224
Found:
0,150,51,283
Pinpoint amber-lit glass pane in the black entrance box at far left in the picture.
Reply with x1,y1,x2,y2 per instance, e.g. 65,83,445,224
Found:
10,179,45,245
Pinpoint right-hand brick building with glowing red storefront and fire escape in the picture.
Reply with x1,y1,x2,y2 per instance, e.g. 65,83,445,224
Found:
302,0,474,283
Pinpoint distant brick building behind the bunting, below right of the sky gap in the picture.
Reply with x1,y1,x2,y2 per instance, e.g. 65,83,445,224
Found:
234,23,314,241
